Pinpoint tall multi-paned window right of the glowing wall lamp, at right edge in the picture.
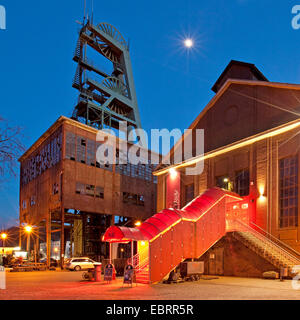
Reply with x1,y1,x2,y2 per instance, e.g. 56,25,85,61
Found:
279,156,298,228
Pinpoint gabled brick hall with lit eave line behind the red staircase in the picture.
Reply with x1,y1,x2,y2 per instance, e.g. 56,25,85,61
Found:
154,61,300,252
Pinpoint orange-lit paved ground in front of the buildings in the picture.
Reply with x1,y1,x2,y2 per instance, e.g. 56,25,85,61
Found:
0,271,300,300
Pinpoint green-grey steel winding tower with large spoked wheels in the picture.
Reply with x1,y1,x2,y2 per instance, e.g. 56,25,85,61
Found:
72,21,141,130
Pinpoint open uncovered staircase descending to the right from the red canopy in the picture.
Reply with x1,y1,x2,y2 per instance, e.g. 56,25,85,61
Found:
232,220,300,276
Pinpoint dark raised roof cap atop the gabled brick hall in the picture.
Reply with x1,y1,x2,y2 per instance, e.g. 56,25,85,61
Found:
212,60,268,93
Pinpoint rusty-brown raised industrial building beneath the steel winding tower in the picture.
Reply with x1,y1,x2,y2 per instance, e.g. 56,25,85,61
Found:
20,117,156,259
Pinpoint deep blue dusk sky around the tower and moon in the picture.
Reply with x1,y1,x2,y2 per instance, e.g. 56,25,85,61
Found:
0,0,300,227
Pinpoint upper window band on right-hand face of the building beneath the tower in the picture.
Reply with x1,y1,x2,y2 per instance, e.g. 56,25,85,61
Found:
66,132,157,183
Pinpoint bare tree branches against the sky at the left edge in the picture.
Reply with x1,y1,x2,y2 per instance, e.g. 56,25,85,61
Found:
0,117,25,177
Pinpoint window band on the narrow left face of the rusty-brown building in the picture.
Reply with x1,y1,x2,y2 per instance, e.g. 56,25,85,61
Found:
21,133,62,185
